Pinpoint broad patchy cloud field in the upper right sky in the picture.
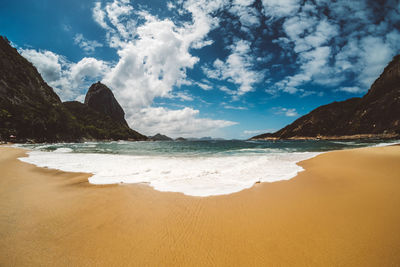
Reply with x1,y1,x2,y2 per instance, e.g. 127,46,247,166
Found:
263,0,400,95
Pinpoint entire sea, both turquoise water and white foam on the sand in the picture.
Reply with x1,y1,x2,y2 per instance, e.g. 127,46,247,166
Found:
16,140,398,197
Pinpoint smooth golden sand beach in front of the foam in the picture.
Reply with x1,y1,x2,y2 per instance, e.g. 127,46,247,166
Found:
0,146,400,266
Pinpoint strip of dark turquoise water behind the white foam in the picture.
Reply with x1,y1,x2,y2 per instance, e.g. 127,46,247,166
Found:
16,140,395,156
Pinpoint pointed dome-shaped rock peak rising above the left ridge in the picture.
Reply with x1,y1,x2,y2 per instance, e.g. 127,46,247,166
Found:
85,82,128,125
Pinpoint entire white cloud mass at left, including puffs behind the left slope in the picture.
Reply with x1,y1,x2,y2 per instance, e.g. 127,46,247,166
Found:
21,0,236,136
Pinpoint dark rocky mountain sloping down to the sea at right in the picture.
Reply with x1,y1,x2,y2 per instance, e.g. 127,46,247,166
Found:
251,55,400,140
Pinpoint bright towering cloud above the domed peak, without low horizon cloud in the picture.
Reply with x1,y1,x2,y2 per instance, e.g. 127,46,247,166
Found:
97,0,227,109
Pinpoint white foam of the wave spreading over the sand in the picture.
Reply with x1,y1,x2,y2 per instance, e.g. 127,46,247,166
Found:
20,150,319,196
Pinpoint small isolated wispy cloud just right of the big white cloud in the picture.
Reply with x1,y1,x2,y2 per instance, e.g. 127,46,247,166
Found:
203,40,264,96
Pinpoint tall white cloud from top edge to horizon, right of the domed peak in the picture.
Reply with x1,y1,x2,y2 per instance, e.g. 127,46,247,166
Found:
93,0,235,136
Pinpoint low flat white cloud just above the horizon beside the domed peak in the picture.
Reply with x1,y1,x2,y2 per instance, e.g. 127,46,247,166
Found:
127,107,237,137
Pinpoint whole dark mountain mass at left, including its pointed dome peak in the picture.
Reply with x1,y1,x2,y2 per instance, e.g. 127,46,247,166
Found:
0,36,147,142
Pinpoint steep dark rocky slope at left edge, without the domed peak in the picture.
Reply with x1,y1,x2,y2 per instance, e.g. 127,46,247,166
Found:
0,36,76,141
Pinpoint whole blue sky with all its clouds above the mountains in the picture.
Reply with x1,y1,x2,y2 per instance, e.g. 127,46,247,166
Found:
0,0,400,139
